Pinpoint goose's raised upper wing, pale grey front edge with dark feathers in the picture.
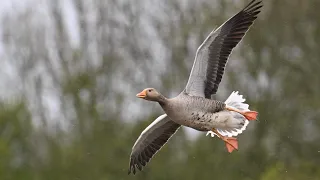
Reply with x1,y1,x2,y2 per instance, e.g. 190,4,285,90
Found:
185,0,262,99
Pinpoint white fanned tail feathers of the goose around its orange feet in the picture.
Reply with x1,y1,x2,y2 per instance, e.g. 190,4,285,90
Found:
206,91,249,137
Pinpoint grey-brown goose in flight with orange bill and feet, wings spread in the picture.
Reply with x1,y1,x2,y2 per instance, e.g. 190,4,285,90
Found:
128,0,262,174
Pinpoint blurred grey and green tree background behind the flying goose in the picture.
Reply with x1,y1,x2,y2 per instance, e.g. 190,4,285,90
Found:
0,0,320,180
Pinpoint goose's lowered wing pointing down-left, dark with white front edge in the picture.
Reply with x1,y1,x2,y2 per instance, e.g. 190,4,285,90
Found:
128,114,180,174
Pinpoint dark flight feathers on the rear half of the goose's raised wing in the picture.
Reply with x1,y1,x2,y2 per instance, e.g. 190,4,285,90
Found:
204,0,263,98
